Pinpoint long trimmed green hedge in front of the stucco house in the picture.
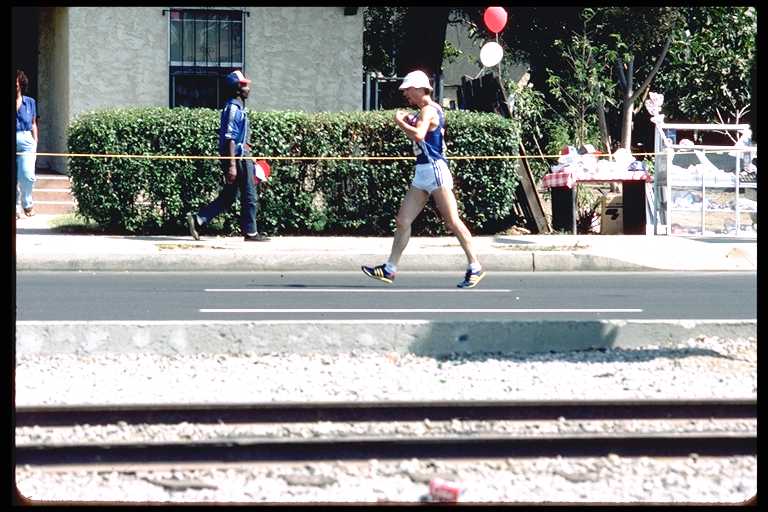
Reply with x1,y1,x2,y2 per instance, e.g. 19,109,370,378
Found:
68,108,519,236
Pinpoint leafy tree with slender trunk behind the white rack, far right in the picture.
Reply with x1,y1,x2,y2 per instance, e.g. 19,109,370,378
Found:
531,6,757,148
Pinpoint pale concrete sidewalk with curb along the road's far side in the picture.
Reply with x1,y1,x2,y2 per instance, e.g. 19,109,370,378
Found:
15,214,757,272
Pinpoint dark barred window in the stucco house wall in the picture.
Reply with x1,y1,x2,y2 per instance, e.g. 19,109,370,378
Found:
168,9,245,108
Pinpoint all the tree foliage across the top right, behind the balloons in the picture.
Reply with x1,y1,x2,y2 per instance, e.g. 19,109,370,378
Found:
364,6,757,149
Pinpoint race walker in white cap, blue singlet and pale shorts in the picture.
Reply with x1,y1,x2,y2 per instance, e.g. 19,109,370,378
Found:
361,70,485,288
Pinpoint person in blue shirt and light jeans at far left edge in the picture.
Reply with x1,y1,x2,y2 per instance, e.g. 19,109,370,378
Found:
16,69,39,219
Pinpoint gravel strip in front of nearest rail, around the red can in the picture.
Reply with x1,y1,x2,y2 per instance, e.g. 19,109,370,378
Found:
16,456,757,503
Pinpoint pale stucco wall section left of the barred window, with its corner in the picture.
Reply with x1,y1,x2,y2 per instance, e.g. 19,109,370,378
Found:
38,7,168,173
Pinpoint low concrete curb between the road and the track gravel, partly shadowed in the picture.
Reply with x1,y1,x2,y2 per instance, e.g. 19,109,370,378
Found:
16,320,757,356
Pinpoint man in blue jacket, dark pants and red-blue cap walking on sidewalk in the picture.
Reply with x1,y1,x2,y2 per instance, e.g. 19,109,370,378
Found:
187,70,269,242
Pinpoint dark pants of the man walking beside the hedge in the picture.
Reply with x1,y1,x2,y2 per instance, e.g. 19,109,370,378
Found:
197,158,259,235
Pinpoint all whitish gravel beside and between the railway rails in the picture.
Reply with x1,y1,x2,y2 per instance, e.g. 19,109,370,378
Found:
15,337,757,503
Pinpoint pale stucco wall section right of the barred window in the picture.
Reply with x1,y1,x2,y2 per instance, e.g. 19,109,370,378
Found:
245,7,363,112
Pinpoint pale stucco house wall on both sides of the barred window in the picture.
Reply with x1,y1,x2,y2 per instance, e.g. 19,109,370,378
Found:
33,6,363,172
